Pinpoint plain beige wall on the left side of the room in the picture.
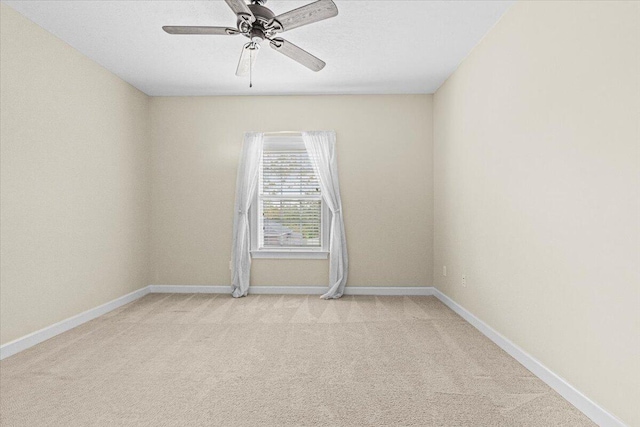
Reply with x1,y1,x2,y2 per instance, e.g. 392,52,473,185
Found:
0,4,149,343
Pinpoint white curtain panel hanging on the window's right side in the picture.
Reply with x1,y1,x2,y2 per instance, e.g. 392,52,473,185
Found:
302,132,349,299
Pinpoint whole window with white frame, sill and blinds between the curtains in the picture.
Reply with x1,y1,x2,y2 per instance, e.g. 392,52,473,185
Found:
251,135,330,258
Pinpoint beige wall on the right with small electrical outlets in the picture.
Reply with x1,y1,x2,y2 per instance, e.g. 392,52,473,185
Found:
434,2,640,425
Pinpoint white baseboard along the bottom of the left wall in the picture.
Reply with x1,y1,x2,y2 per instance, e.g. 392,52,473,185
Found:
0,286,149,360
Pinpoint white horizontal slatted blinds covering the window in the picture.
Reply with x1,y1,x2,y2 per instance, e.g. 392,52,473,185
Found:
258,145,323,249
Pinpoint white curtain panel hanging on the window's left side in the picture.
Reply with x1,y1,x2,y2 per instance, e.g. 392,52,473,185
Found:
231,132,263,298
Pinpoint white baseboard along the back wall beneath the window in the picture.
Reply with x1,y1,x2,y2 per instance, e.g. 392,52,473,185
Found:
149,285,435,296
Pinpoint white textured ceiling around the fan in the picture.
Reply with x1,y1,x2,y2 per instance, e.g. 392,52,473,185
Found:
4,0,512,96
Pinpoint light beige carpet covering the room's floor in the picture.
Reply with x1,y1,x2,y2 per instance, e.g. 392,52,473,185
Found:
0,294,593,427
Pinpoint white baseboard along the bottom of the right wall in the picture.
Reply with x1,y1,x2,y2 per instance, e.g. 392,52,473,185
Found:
433,288,625,427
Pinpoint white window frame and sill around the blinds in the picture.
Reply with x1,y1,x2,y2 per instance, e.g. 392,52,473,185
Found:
249,133,332,259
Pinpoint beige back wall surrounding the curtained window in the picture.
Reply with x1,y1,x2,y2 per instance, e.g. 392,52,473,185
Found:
151,95,433,286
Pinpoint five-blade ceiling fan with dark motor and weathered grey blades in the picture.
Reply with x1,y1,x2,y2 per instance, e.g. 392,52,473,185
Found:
162,0,338,87
